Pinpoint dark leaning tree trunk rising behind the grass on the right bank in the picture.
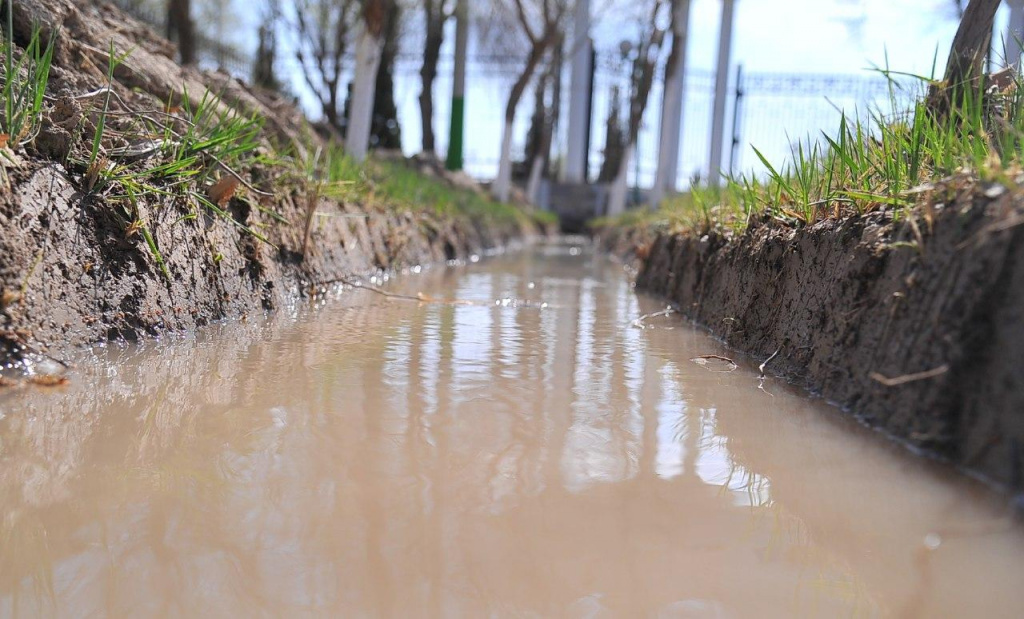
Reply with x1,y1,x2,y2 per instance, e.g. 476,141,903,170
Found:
929,0,1001,116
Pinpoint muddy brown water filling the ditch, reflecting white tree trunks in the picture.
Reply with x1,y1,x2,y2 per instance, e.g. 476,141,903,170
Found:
0,242,1024,617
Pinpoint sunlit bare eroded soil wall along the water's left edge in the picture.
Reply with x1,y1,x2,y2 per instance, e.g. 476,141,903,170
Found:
0,165,530,364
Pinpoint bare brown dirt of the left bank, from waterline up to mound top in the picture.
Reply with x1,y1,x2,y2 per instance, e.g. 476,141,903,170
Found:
0,0,532,365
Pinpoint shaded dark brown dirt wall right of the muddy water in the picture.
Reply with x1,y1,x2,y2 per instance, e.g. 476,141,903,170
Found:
604,183,1024,492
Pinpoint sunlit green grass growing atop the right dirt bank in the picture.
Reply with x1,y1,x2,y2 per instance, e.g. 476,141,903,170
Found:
604,71,1024,236
